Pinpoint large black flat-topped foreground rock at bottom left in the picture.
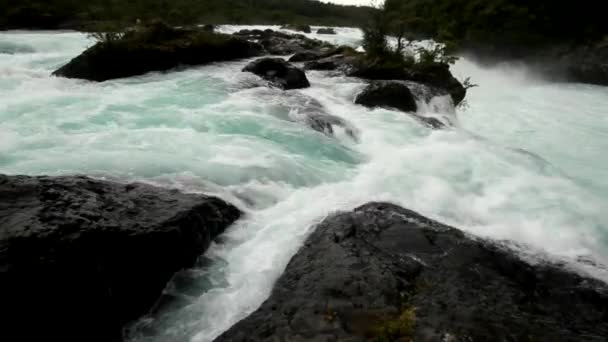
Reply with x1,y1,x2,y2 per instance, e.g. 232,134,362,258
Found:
0,175,240,342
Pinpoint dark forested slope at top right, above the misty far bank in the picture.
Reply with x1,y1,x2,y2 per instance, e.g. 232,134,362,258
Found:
385,0,608,47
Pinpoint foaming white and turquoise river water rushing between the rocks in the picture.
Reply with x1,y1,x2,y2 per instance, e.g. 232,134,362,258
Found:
0,27,608,342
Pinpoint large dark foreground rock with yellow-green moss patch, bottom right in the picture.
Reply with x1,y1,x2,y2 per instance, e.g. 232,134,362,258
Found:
216,203,608,342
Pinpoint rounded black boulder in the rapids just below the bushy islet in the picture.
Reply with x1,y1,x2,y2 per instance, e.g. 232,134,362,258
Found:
355,81,418,112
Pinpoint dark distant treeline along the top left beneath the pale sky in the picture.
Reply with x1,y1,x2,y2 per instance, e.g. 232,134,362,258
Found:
0,0,372,27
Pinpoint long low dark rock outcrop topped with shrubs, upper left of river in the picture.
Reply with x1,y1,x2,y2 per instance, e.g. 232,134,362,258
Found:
53,23,262,81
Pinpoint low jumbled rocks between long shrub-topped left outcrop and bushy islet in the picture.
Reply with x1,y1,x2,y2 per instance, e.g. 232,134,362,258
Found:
234,29,333,56
